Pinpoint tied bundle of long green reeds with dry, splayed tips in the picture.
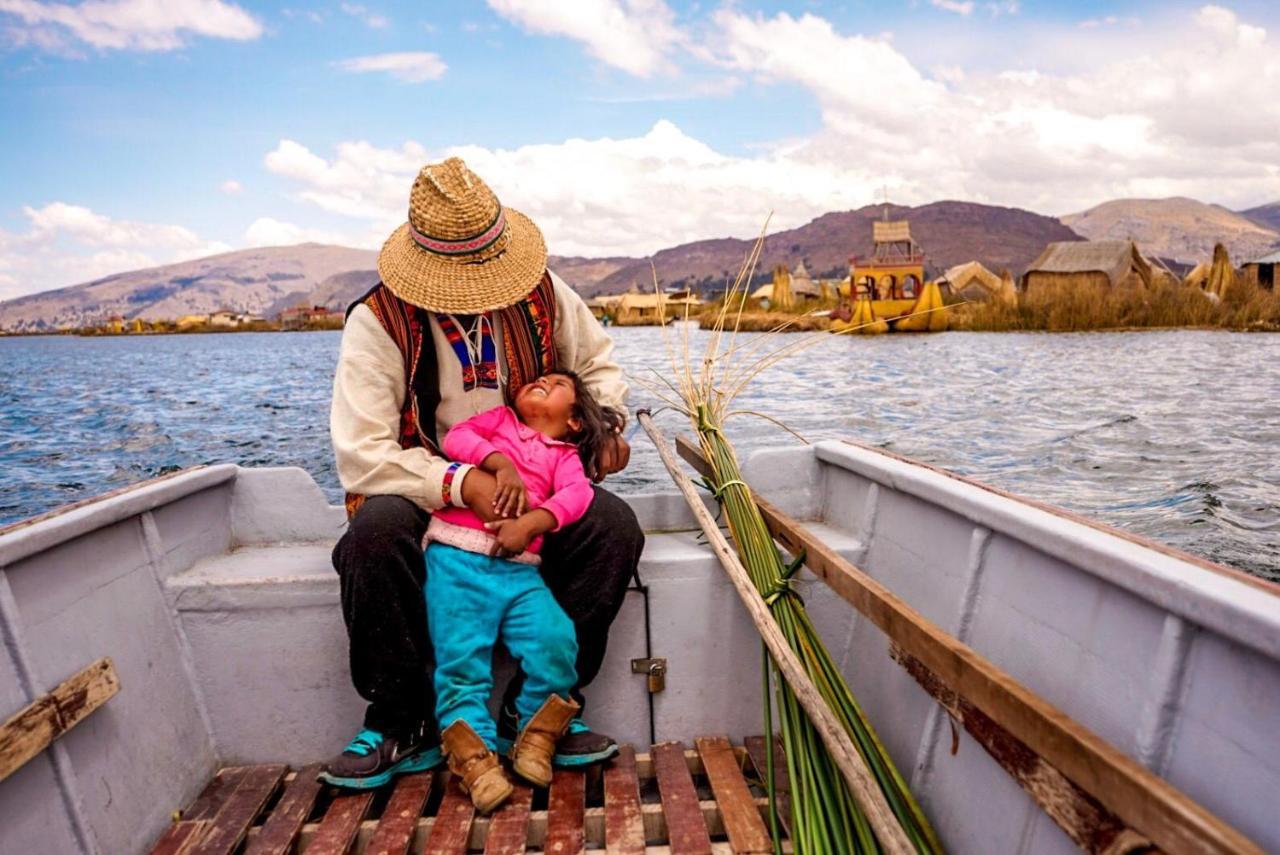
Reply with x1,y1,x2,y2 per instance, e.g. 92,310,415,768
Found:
646,234,942,855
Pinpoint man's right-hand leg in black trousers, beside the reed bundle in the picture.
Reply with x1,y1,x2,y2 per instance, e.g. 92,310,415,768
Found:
499,486,644,765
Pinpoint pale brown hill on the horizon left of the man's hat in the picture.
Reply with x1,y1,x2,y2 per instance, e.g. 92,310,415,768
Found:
0,243,376,332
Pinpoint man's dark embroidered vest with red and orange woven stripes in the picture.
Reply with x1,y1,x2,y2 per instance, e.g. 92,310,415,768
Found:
347,273,557,518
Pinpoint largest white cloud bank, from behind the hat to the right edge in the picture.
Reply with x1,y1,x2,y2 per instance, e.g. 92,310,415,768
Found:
259,6,1280,261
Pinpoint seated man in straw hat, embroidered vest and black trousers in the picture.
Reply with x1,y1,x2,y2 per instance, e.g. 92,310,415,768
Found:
321,157,644,788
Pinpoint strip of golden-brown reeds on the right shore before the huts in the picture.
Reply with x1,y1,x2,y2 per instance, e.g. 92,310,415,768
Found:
951,282,1280,332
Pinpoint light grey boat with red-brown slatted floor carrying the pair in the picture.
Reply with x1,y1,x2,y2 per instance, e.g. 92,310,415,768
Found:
0,442,1280,855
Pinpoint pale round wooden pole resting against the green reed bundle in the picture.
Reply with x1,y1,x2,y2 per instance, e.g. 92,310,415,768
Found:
636,411,915,855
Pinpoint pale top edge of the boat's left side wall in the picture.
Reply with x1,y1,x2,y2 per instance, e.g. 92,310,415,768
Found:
0,463,241,568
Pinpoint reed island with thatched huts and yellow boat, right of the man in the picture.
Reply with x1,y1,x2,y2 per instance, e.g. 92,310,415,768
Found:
589,229,1280,334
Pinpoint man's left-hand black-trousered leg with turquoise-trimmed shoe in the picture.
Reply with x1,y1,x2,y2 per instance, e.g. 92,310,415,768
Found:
325,495,439,786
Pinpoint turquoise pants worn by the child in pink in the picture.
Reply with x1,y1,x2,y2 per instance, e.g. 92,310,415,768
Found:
424,543,577,749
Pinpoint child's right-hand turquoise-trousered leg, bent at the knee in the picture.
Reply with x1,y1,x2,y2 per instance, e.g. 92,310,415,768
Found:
502,567,577,726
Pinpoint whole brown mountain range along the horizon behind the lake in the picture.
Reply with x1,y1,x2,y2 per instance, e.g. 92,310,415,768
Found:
0,198,1280,332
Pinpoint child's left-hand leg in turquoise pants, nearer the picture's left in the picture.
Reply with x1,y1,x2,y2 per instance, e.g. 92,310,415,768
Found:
425,543,507,749
